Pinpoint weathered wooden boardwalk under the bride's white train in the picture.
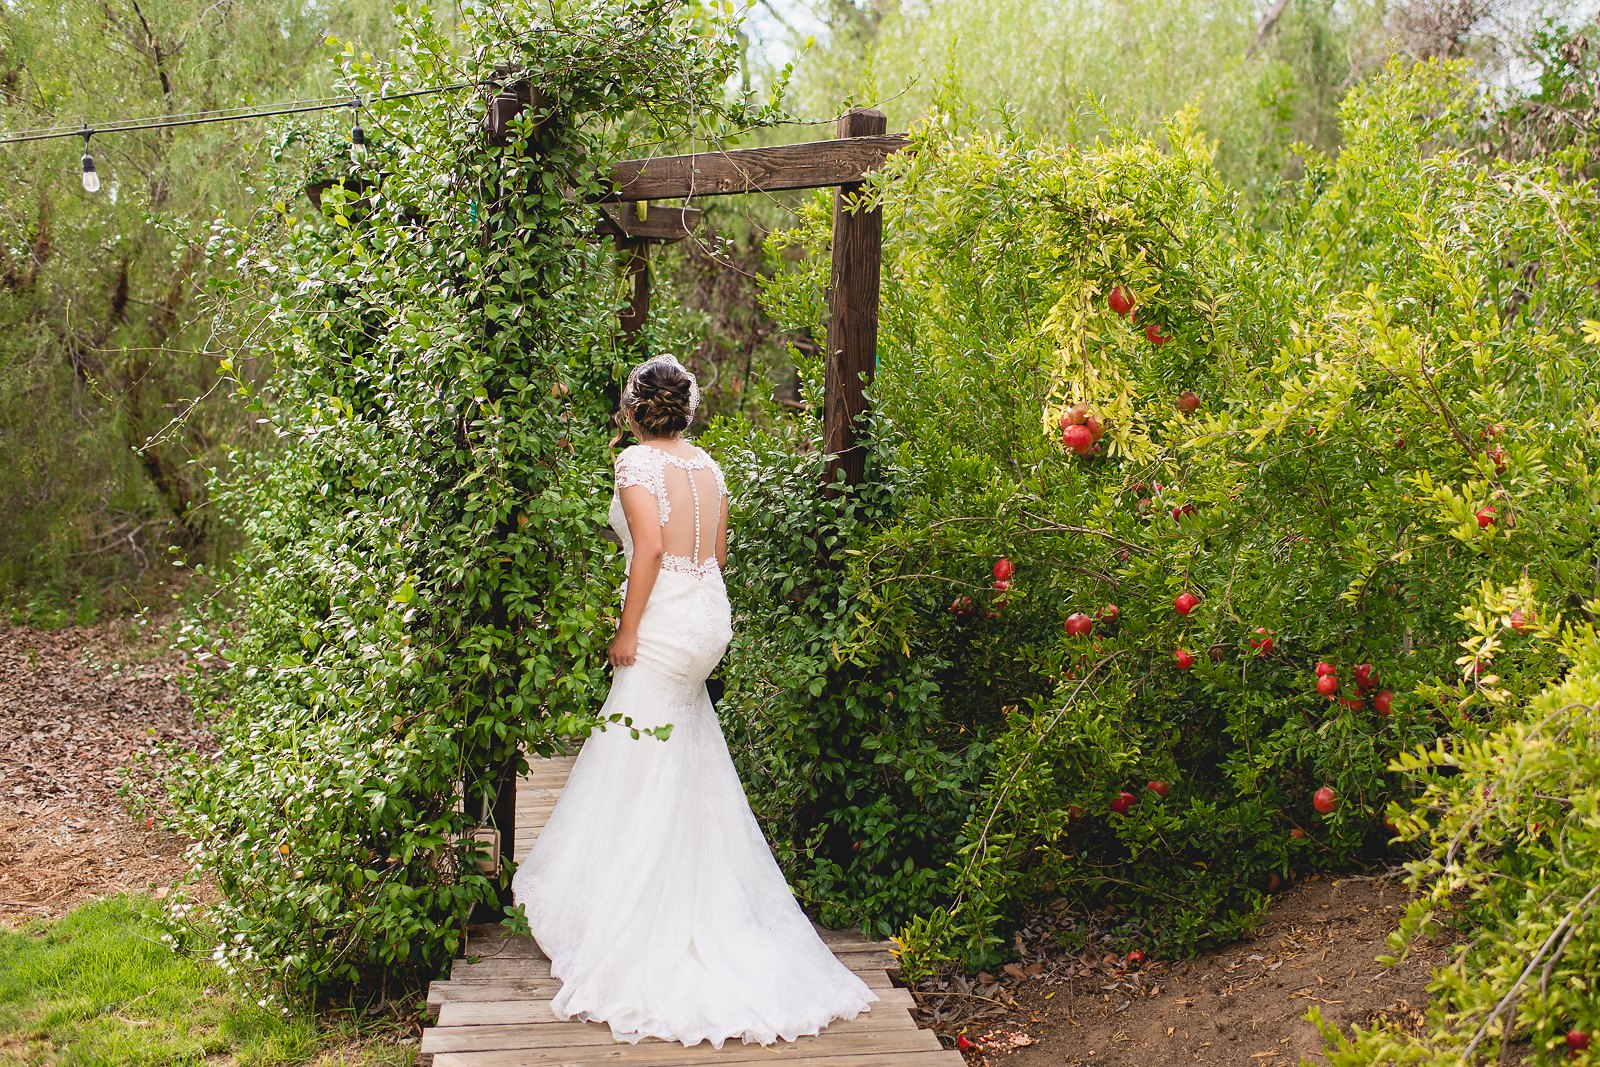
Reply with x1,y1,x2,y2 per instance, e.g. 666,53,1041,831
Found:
421,757,965,1067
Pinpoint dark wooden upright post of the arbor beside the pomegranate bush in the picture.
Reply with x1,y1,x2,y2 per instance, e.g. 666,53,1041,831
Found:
822,107,888,493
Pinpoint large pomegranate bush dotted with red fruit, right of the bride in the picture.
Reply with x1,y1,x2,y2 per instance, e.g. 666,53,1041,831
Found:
715,56,1600,974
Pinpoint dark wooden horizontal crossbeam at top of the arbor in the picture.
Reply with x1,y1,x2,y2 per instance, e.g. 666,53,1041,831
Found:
602,133,910,203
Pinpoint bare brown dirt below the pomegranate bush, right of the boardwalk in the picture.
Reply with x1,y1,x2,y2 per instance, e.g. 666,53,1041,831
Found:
939,877,1446,1067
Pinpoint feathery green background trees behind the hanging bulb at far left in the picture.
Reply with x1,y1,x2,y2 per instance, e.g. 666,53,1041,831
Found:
0,0,387,614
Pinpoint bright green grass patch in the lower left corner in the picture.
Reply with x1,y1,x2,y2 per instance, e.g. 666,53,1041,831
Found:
0,894,416,1067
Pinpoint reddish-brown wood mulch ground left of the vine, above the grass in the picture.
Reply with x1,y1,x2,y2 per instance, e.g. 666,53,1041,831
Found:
0,621,206,926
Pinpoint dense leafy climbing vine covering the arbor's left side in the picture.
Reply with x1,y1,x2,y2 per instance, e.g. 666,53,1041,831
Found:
159,0,776,993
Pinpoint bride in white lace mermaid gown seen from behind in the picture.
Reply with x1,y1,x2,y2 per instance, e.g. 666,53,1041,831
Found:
512,357,878,1048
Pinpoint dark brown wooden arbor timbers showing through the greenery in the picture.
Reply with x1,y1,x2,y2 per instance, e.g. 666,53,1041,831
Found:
467,99,910,905
